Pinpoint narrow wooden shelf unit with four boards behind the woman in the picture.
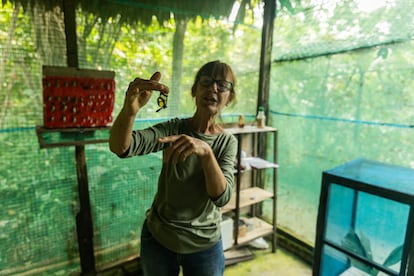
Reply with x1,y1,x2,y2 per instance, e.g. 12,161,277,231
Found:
222,126,278,252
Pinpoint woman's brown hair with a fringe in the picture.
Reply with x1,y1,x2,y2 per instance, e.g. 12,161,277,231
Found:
191,60,236,102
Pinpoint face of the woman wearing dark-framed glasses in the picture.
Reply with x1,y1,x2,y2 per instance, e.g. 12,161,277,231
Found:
194,75,233,115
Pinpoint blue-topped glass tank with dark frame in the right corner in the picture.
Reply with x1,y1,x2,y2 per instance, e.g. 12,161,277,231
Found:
314,159,414,276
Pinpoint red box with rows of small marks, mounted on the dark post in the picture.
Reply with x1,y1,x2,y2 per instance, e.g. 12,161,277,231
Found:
43,76,115,128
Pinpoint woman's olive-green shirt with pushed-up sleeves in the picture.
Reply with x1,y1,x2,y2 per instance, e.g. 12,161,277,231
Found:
125,118,237,253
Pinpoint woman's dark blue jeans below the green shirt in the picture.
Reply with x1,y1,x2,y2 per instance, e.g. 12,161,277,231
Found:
140,221,224,276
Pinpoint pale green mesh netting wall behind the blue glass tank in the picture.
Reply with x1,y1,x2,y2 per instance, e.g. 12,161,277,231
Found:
269,0,414,243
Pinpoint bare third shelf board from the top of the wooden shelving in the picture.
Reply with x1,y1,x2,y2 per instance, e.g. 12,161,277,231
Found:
221,187,274,213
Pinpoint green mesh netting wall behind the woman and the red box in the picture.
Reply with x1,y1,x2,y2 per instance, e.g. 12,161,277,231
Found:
0,0,261,275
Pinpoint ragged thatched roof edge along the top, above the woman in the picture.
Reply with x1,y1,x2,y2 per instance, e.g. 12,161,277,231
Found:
2,0,243,24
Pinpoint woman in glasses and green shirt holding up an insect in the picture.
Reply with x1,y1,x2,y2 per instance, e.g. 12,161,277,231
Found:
109,61,237,276
